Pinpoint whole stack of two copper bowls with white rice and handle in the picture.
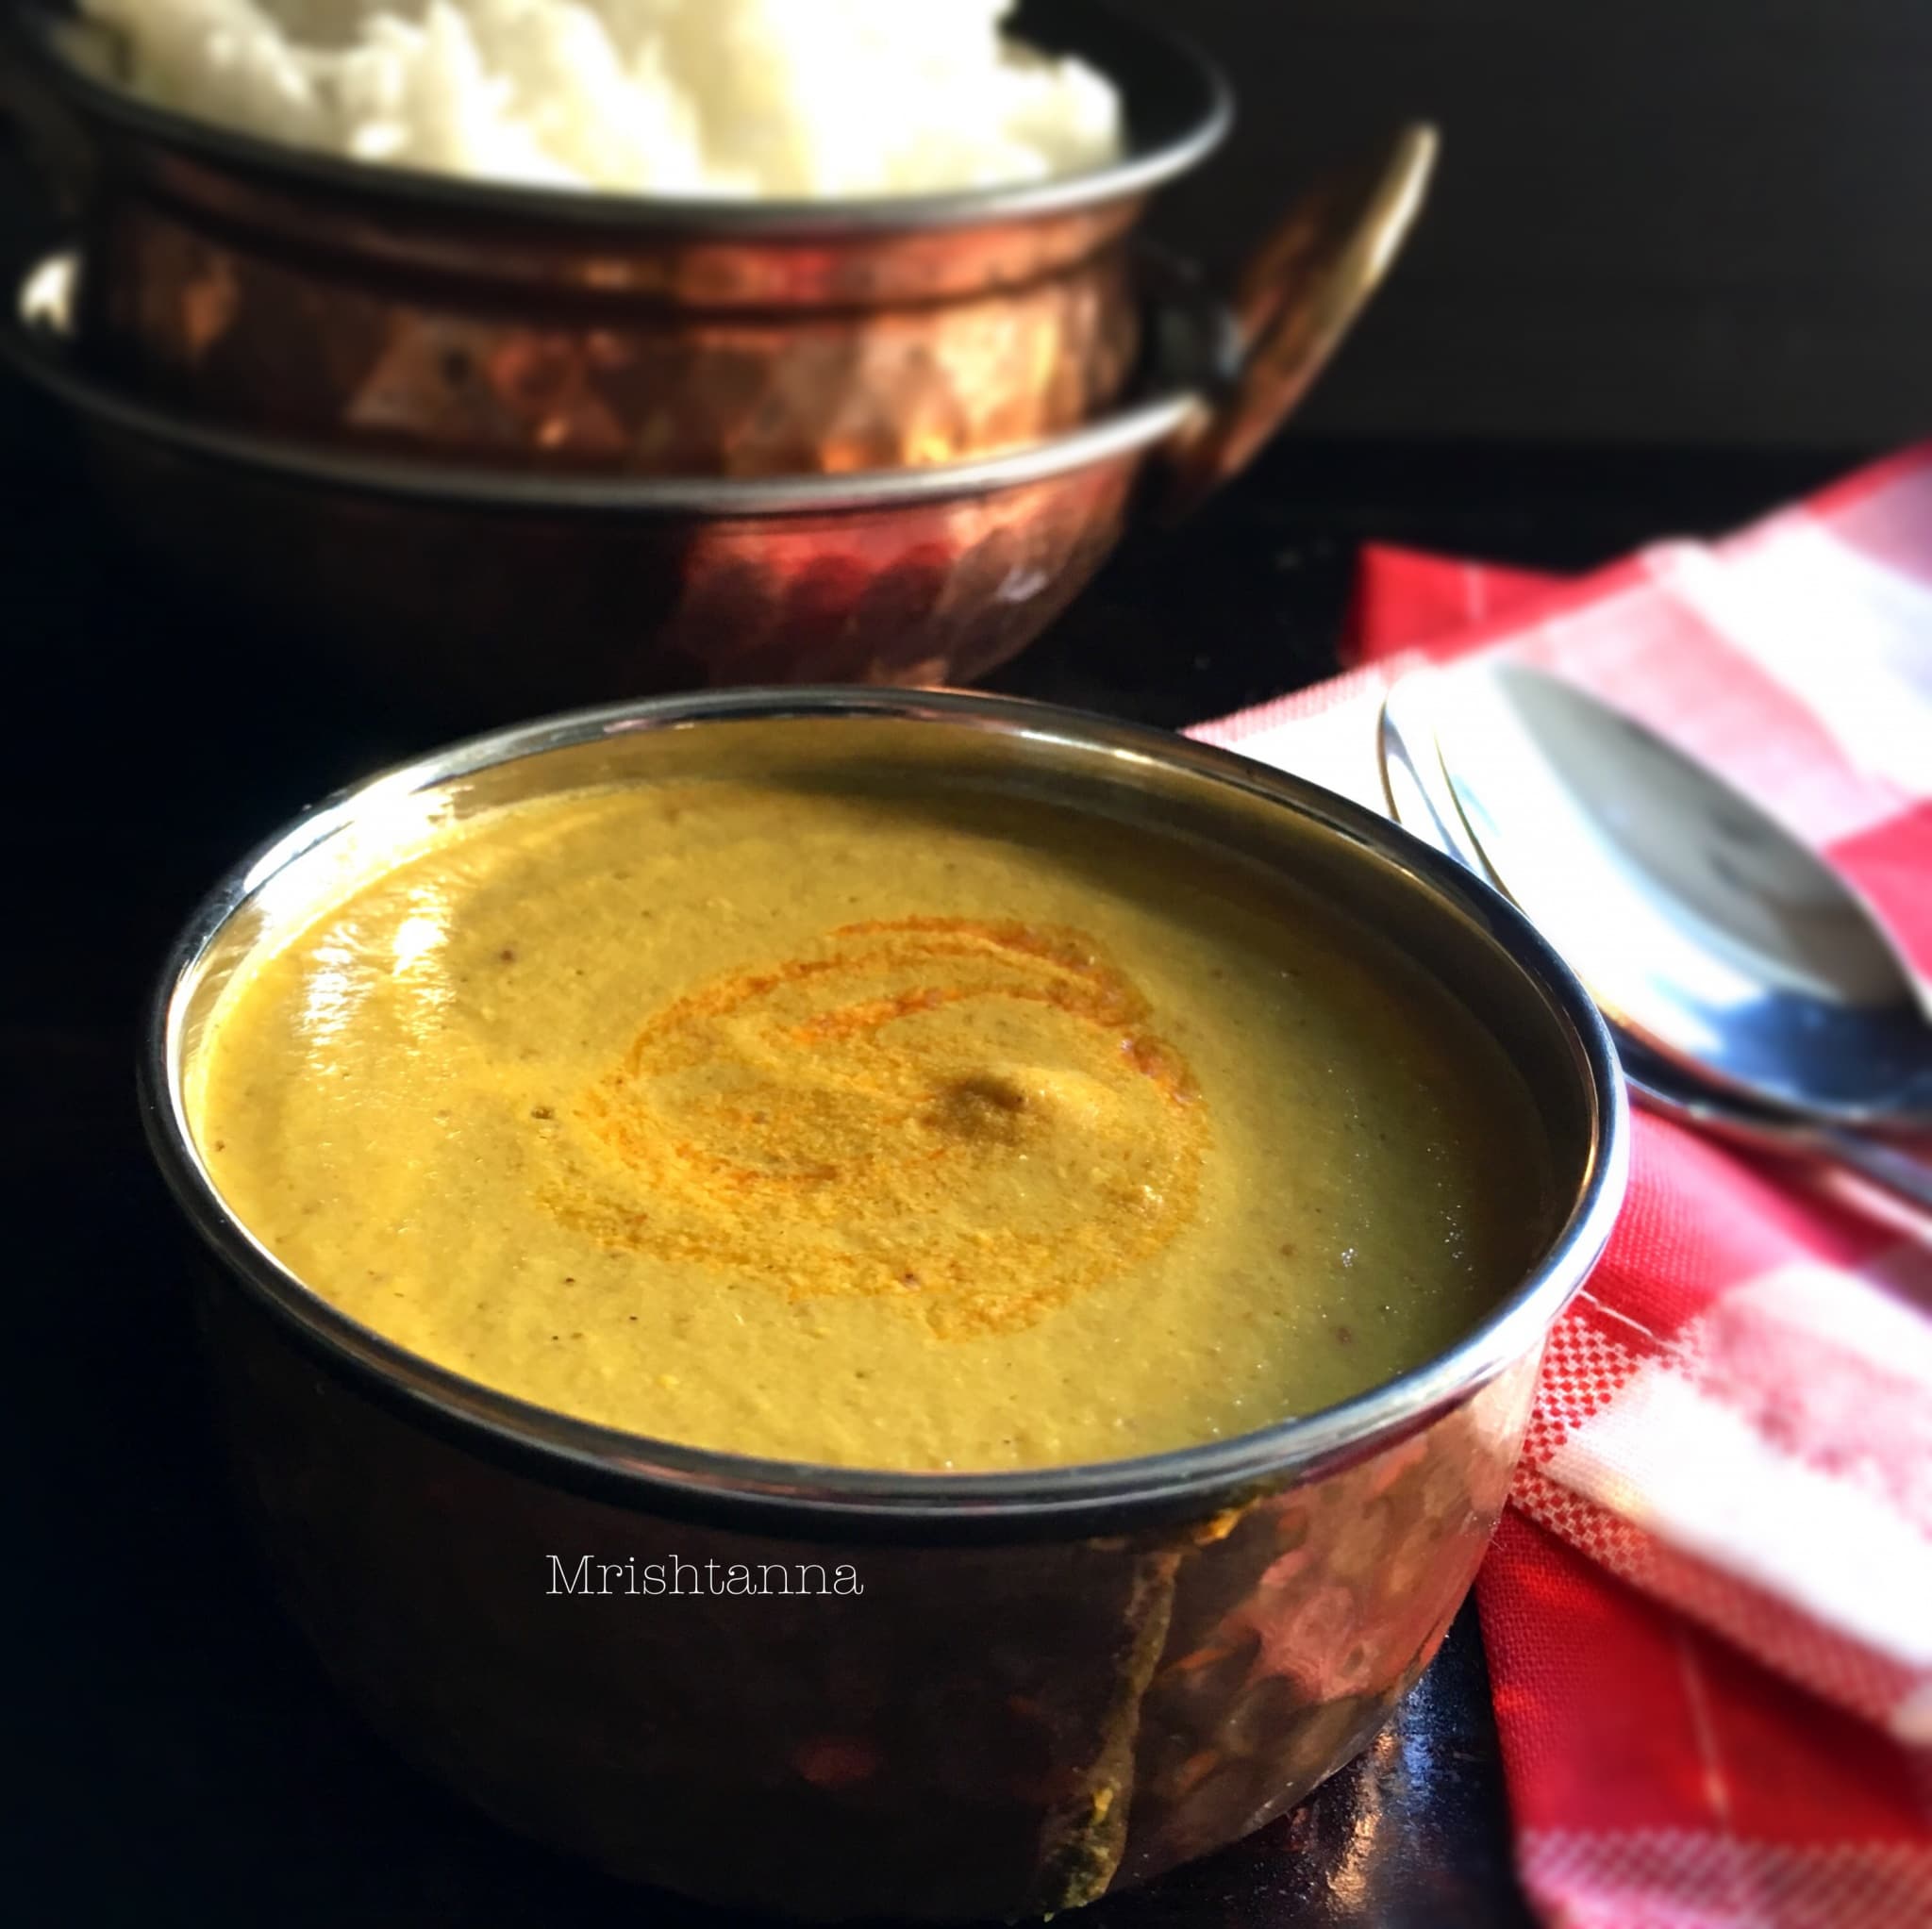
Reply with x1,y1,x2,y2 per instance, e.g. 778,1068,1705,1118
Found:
0,0,1436,710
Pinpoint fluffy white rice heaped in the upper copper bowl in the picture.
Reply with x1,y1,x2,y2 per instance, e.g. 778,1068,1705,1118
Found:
83,0,1123,199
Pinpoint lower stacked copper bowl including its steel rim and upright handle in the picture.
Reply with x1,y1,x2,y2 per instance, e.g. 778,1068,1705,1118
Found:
0,127,1434,723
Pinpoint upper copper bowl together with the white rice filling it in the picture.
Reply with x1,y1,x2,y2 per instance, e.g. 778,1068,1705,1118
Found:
13,0,1229,477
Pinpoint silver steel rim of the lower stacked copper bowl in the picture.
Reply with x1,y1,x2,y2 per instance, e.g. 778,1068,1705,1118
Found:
0,249,1209,520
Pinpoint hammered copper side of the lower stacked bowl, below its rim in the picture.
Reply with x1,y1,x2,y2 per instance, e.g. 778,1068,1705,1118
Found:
100,439,1141,724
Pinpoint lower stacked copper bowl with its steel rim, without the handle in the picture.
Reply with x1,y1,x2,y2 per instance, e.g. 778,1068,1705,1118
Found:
0,257,1194,710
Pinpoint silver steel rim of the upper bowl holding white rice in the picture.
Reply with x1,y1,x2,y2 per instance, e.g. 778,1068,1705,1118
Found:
17,0,1235,241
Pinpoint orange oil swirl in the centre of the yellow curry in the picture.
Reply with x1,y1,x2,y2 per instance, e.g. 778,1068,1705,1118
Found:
547,917,1208,1339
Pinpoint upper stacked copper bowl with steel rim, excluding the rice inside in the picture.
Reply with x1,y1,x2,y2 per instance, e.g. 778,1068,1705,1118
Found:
4,0,1231,475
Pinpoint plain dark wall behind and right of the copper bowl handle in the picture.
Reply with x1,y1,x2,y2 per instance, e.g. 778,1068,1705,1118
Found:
1121,0,1932,448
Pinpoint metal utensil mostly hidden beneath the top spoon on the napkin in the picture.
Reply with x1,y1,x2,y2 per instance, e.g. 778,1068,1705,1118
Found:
1381,672,1932,1213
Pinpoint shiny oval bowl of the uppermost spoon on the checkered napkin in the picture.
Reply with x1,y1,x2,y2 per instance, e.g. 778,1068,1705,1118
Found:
1434,662,1932,1125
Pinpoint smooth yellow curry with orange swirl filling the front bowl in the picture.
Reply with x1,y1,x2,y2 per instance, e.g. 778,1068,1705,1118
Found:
186,758,1552,1472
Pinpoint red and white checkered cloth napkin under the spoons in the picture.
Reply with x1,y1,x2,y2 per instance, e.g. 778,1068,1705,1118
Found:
1196,444,1932,1929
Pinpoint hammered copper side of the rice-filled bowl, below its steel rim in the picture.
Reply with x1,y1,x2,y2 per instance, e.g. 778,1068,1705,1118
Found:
87,160,1140,475
